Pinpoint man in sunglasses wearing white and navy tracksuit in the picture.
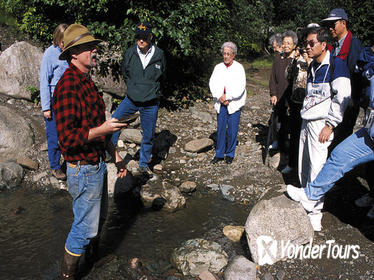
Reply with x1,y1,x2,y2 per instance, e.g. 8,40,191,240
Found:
298,28,351,230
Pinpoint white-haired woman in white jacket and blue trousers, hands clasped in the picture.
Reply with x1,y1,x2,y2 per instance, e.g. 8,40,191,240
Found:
209,42,247,164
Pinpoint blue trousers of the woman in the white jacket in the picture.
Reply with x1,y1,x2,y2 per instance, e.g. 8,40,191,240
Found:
216,105,241,158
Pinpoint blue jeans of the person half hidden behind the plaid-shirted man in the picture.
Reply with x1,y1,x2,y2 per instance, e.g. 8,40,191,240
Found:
44,111,61,170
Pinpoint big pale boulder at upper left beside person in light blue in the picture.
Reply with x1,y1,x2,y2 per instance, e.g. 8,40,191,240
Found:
0,42,43,100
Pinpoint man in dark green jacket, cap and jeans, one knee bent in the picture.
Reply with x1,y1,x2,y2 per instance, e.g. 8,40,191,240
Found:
112,22,166,177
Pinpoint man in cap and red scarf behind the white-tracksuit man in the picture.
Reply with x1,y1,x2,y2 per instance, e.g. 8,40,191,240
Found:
322,8,362,150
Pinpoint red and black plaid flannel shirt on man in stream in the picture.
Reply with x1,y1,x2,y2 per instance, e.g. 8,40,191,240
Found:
53,64,105,163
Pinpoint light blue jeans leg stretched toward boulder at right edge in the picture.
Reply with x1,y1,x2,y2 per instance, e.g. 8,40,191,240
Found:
305,128,374,200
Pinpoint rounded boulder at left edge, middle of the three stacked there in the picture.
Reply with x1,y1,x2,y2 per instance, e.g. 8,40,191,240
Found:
0,106,34,162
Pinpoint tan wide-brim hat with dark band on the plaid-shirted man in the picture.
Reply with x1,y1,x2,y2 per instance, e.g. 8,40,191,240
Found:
58,24,102,60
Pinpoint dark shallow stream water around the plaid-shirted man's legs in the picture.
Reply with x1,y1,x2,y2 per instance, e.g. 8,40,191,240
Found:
0,185,249,279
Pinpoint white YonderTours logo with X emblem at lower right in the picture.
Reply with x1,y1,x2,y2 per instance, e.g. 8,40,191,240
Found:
256,235,360,265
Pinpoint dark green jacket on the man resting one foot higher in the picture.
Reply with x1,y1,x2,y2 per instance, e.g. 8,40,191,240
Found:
122,44,166,103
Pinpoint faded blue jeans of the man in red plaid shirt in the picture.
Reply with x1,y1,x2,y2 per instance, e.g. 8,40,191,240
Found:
65,161,108,256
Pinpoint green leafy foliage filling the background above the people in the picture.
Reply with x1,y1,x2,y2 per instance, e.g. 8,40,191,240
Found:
0,0,374,107
